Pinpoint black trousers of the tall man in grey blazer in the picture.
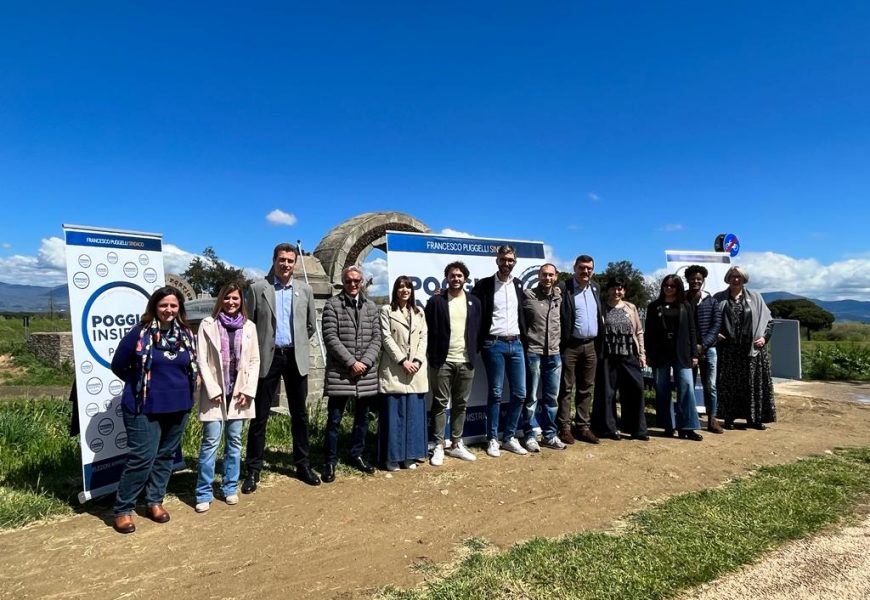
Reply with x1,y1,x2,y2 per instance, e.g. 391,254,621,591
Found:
245,348,309,473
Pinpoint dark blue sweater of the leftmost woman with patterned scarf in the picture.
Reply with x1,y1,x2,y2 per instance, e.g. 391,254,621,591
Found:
112,325,193,414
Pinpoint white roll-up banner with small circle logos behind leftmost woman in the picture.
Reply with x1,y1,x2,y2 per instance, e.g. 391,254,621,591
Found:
63,225,164,502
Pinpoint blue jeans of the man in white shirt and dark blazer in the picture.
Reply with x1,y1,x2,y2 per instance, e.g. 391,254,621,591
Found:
483,338,526,440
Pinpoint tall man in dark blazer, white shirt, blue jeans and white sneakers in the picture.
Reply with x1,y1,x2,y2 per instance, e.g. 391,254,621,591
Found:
471,246,528,458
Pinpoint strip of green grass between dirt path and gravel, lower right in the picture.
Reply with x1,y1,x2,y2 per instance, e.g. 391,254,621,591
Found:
381,448,870,600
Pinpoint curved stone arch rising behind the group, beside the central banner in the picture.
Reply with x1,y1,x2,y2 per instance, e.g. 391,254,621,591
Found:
314,211,431,285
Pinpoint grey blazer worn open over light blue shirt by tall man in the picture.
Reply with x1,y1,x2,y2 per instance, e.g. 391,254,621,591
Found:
245,277,317,378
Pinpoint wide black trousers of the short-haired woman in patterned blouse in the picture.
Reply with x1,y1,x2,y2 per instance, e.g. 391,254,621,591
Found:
592,356,647,435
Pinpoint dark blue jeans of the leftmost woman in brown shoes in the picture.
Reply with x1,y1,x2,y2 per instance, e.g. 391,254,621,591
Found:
113,407,189,517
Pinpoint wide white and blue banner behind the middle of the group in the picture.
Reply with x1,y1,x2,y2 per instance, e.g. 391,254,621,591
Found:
387,231,546,441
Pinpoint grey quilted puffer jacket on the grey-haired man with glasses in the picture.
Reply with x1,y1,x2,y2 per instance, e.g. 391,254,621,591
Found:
323,292,381,397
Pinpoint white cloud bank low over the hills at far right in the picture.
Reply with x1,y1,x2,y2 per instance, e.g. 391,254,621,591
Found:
646,252,870,301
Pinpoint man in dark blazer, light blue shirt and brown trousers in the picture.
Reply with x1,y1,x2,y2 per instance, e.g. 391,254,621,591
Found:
556,254,604,444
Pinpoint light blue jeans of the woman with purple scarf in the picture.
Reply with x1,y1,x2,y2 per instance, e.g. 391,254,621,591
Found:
196,419,245,502
